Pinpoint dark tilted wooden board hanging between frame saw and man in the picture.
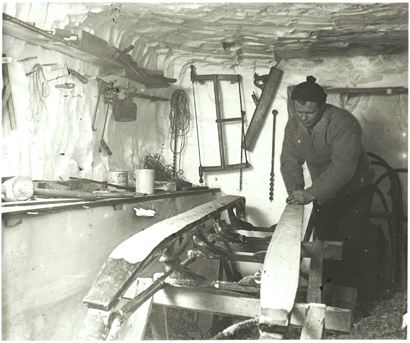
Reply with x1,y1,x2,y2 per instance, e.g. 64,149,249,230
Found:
244,67,283,151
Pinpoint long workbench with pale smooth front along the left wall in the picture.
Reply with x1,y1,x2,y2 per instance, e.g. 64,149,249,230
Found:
1,189,220,340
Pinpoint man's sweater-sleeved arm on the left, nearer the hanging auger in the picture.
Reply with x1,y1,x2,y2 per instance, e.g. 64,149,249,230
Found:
280,120,305,194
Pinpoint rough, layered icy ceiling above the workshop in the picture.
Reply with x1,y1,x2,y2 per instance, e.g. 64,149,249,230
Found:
76,2,408,62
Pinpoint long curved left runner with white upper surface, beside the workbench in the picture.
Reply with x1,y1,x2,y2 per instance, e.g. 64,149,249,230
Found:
83,195,245,309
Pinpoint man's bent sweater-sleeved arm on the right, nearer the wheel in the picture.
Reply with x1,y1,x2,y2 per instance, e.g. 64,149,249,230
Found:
306,120,362,204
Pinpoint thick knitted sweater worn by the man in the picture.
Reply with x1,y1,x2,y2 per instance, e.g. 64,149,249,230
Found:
281,104,374,204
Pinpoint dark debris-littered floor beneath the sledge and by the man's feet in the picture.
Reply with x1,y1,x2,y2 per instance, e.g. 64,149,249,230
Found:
144,292,407,340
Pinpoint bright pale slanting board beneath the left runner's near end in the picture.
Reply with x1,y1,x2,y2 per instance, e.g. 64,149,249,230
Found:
118,278,153,341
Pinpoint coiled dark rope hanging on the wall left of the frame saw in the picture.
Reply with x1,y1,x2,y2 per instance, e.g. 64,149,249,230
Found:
169,90,191,176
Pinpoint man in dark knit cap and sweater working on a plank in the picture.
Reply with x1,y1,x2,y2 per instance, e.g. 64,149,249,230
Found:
281,76,374,318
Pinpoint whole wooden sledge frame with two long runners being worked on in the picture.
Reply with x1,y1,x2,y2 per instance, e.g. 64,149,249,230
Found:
80,195,352,340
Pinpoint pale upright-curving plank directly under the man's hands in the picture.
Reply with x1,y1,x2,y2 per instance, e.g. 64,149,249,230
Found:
261,205,303,326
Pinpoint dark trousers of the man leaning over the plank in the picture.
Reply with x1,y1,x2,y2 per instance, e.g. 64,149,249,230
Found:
313,185,377,301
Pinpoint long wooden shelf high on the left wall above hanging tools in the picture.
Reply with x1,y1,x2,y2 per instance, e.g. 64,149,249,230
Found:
3,13,176,88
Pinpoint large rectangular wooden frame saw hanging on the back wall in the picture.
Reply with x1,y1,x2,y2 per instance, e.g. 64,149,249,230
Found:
190,65,250,183
